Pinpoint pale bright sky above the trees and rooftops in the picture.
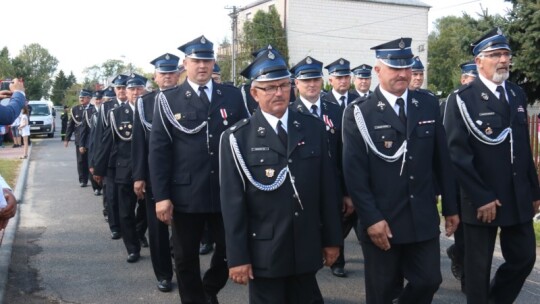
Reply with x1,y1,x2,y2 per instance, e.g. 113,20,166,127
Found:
0,0,511,81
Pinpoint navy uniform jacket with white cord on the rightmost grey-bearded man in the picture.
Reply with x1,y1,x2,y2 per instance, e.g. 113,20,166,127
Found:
444,77,540,226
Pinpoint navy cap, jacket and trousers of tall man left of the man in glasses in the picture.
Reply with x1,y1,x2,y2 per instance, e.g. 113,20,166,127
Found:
149,36,248,303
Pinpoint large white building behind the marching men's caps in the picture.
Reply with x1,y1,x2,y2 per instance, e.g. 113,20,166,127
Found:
238,0,430,88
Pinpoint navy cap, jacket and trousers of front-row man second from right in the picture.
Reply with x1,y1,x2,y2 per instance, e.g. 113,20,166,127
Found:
343,38,457,304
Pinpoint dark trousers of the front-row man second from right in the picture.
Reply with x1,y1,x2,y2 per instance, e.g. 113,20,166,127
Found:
362,237,442,304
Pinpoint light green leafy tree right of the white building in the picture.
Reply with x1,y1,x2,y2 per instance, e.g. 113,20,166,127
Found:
428,9,507,96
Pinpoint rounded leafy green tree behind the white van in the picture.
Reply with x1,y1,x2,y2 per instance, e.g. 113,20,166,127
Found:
12,43,58,100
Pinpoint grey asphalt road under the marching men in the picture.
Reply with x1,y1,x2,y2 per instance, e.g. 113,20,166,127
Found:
4,125,540,304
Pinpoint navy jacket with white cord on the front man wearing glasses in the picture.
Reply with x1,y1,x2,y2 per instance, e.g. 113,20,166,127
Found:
221,109,343,278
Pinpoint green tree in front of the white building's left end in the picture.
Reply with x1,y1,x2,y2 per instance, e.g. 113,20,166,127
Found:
236,7,289,83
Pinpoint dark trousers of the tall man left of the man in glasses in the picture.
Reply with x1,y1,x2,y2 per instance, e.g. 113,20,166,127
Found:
172,212,229,304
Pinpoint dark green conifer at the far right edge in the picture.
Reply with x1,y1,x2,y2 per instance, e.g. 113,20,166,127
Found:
505,0,540,103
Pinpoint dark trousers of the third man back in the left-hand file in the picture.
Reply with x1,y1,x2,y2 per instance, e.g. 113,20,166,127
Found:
116,184,141,254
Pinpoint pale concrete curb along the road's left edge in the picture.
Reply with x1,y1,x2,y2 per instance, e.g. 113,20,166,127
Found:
0,146,32,304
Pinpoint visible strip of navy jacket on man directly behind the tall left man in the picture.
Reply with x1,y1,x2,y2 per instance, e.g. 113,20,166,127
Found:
131,91,157,184
